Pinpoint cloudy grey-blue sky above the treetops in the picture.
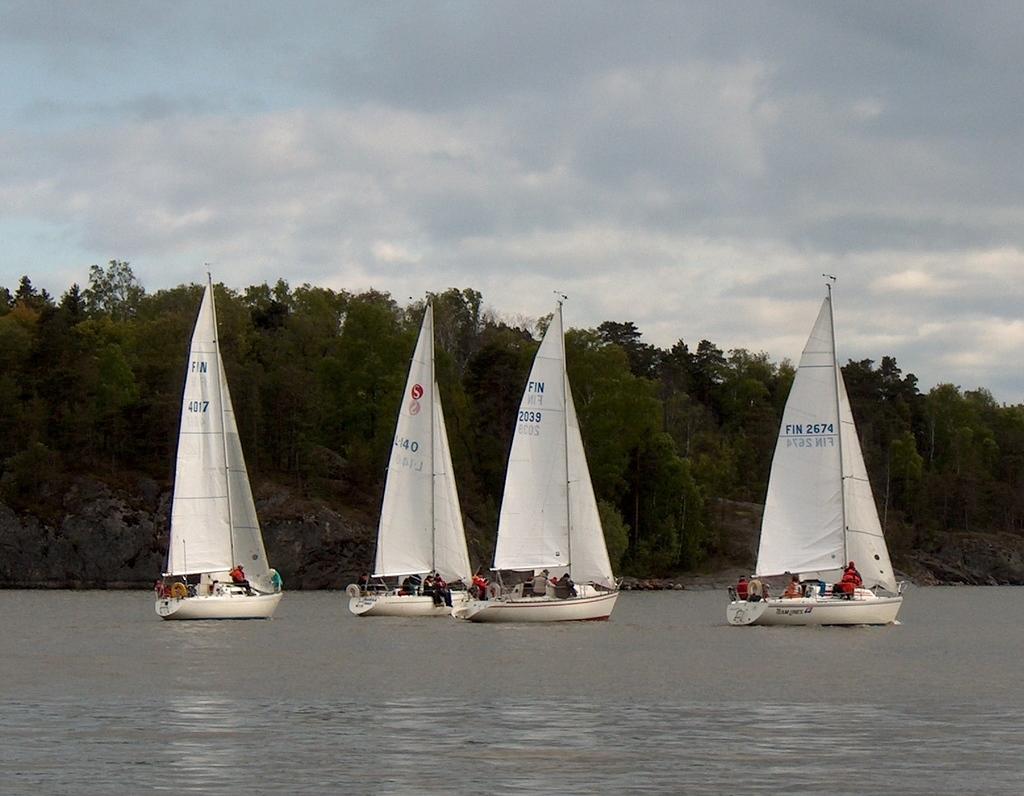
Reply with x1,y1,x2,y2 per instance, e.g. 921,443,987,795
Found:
0,0,1024,404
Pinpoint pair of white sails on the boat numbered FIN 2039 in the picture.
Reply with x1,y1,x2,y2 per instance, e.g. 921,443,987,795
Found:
495,306,614,587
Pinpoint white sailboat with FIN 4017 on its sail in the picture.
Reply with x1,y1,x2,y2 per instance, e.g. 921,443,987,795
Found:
156,275,282,619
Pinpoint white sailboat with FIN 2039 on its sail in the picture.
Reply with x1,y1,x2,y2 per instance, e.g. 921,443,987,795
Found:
452,301,618,622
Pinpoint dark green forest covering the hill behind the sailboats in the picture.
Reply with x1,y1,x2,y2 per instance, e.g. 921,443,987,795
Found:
0,260,1024,576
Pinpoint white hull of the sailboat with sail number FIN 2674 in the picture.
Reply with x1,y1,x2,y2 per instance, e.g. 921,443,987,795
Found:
726,591,903,627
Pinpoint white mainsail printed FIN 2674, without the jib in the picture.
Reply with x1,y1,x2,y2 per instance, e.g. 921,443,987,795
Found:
757,298,846,575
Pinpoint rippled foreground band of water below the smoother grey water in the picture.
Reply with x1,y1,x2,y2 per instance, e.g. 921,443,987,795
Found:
0,696,1024,796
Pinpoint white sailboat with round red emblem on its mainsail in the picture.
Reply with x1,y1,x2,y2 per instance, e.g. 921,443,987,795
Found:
346,304,472,617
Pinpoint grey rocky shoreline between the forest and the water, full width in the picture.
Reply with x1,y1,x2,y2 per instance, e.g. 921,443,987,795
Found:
0,477,1024,591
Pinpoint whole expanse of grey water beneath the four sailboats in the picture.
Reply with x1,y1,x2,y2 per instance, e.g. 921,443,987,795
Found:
0,588,1024,796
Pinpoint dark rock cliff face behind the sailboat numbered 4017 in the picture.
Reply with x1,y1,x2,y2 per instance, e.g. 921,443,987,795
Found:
0,471,376,589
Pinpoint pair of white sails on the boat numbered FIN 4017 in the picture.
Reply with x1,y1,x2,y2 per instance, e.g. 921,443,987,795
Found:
167,281,271,591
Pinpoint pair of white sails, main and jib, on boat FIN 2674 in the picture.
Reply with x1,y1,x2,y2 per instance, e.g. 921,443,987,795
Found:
757,294,896,591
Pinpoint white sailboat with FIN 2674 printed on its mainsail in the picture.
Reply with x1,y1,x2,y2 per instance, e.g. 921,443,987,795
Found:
726,278,903,625
